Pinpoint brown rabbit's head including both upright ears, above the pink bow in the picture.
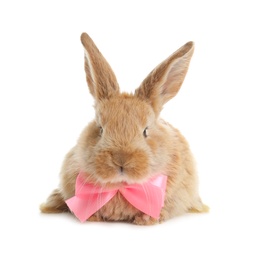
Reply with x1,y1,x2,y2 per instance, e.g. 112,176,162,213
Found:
78,33,194,184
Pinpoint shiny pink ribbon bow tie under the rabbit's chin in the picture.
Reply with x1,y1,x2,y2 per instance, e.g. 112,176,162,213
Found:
66,173,167,222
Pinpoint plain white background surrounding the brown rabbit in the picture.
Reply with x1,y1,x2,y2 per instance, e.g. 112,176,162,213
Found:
0,0,257,260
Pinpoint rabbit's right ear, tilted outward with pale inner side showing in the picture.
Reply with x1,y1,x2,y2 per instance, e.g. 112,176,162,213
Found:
135,42,194,113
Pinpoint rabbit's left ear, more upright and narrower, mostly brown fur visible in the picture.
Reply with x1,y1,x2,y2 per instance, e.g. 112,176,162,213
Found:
81,33,119,100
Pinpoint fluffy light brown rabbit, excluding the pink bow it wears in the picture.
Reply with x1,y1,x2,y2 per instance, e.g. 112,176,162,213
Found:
40,33,208,225
